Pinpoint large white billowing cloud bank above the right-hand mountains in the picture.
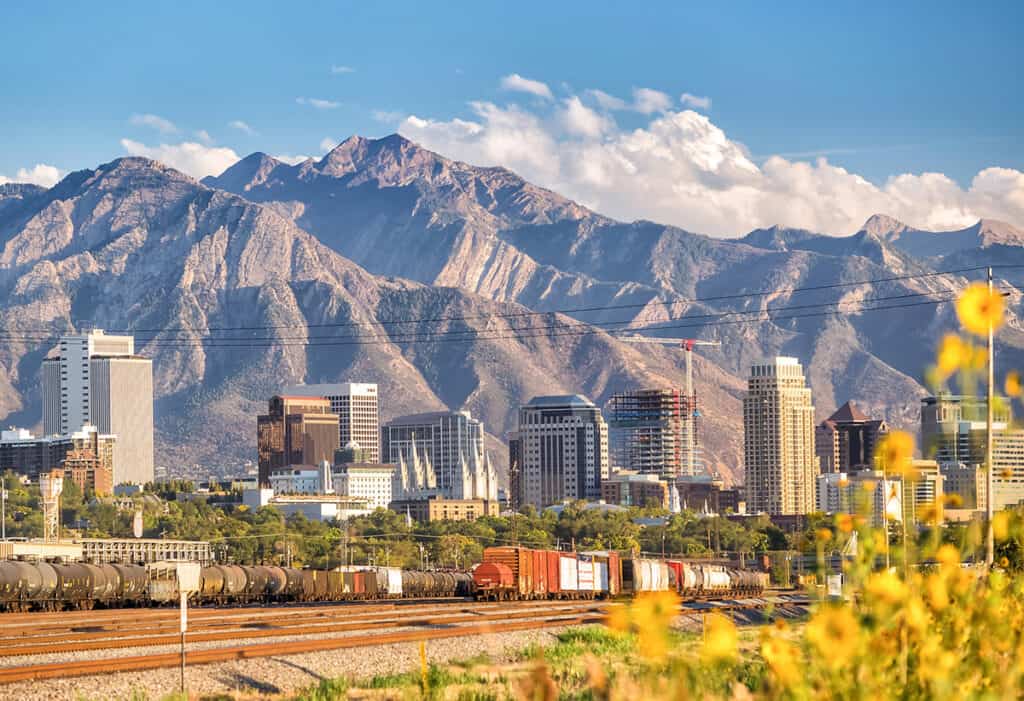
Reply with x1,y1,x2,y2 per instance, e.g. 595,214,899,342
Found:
398,81,1024,235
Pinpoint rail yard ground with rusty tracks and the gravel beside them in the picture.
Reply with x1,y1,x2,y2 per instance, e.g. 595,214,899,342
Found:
0,592,808,699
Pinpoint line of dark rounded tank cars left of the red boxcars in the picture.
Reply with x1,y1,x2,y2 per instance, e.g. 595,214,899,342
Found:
0,560,473,611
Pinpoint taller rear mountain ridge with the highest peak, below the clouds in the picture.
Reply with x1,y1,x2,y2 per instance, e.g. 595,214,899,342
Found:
207,135,1024,433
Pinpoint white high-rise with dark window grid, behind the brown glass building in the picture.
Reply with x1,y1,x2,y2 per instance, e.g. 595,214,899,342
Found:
282,382,381,463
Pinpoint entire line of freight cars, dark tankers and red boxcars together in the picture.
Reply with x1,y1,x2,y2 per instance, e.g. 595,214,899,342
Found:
0,546,768,611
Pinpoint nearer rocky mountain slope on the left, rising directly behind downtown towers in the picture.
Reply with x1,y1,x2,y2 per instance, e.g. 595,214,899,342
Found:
0,159,753,478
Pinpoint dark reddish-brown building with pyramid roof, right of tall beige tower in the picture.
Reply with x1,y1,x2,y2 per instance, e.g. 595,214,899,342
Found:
814,401,889,473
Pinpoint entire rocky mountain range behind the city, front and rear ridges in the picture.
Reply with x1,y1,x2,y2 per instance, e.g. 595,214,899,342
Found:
0,135,1024,487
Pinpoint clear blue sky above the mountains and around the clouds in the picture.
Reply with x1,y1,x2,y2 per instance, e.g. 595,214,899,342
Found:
0,1,1024,236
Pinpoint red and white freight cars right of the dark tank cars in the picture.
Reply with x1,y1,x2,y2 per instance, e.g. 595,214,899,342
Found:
473,546,768,601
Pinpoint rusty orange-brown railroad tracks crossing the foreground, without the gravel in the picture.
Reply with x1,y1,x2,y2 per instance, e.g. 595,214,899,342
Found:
0,595,811,685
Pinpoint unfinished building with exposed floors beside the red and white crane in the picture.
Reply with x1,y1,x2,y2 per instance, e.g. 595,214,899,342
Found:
607,389,700,477
